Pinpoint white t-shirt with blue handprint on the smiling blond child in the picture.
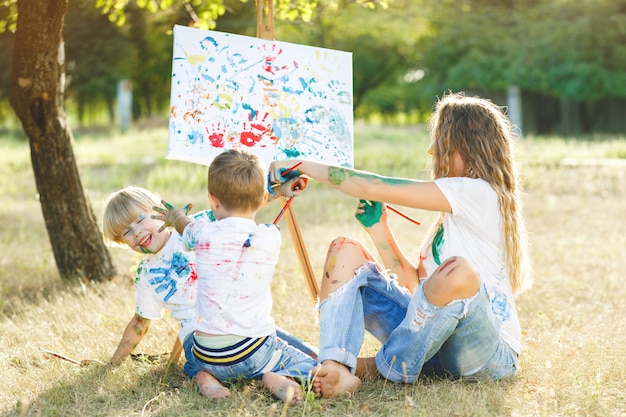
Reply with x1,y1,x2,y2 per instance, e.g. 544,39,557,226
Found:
135,210,215,342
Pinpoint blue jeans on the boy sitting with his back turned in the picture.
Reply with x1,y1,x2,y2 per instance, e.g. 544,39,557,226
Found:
183,328,317,382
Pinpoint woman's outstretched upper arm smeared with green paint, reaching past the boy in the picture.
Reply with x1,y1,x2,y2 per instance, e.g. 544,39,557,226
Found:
270,159,452,213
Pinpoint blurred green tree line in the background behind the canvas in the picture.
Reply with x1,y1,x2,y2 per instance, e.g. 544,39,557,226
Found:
0,0,626,134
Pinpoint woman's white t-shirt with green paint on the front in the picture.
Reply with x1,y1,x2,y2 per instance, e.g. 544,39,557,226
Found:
421,177,522,353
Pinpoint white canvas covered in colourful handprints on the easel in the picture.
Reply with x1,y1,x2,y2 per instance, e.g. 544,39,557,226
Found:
167,26,353,167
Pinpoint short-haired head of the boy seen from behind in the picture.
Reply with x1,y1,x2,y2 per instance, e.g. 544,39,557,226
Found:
208,148,267,211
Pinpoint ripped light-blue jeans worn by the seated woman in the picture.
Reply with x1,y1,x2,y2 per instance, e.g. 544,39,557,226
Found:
318,263,518,383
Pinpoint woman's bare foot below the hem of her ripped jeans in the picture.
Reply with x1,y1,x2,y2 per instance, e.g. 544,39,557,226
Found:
312,361,361,398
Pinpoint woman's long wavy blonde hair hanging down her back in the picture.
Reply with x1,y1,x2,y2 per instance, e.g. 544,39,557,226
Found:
430,93,532,294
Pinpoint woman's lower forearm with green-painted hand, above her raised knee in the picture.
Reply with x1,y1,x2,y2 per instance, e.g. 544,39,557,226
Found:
354,200,419,293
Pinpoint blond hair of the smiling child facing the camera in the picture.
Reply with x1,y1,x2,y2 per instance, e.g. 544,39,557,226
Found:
102,186,161,243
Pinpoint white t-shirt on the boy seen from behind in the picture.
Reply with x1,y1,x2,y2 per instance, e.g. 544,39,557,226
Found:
183,217,281,337
